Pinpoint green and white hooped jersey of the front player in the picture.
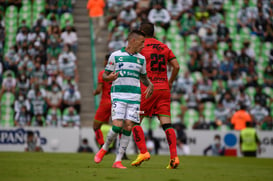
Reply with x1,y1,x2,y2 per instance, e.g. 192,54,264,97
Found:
105,48,146,104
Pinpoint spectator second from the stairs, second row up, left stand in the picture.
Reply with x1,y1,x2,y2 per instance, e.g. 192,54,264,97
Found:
46,83,63,109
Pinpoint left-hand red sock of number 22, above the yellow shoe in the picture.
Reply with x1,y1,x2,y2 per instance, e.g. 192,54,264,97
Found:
132,125,148,154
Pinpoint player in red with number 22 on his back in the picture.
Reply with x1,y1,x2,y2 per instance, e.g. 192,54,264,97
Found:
131,23,180,169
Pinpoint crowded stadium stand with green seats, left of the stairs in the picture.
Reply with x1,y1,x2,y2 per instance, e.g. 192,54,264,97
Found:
0,0,80,127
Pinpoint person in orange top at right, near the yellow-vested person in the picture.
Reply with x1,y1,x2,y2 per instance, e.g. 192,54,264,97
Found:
231,103,253,131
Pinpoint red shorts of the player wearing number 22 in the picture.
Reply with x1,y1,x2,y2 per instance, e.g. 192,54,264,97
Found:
140,89,171,117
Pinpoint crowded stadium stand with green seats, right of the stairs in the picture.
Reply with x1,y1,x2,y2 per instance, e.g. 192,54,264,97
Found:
102,0,273,130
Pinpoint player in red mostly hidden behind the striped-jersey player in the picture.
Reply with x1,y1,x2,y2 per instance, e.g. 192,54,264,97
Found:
93,54,112,146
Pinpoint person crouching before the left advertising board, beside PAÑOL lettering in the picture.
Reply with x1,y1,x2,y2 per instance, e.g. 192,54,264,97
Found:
25,131,43,152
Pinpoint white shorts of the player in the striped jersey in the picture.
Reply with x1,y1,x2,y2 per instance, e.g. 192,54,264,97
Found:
112,101,140,123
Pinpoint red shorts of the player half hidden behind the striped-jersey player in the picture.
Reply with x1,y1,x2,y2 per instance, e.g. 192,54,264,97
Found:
95,102,112,123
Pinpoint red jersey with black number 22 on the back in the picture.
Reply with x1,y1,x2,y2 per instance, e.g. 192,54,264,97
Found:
140,38,176,89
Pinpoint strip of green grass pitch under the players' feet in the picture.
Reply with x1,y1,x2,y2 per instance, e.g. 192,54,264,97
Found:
0,152,273,181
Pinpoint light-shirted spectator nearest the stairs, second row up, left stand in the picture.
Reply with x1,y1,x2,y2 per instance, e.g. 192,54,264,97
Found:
63,84,81,113
